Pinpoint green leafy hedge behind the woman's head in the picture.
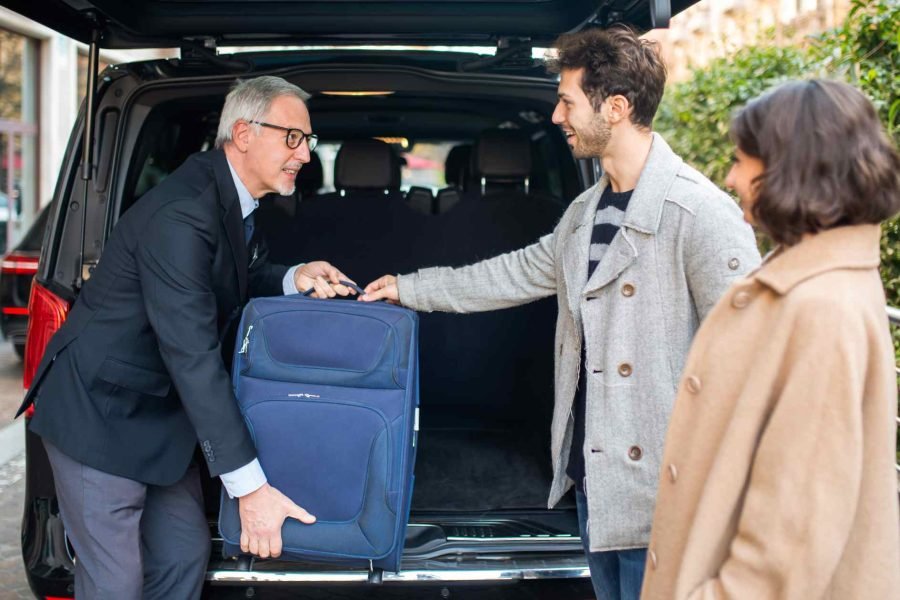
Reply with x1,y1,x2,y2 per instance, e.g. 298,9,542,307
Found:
654,0,900,308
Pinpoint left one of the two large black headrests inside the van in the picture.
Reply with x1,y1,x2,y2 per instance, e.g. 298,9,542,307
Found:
334,140,400,190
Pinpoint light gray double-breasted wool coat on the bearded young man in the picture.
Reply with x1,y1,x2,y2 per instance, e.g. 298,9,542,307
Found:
398,134,760,551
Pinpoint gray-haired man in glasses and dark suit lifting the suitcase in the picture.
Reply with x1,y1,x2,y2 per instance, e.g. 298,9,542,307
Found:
20,77,351,600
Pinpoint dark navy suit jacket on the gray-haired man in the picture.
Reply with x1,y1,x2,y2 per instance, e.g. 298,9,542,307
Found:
22,150,287,485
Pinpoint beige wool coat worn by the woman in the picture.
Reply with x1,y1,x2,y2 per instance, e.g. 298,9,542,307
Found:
641,225,900,600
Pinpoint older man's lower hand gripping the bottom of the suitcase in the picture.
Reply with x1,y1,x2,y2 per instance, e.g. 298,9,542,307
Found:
238,483,316,558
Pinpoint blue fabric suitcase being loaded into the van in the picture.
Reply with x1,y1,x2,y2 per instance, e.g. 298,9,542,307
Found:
219,296,419,571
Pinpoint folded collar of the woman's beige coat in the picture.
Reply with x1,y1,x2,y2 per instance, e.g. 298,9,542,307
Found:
752,224,881,295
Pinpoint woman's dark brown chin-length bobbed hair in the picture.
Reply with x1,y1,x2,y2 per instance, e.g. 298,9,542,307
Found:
731,79,900,245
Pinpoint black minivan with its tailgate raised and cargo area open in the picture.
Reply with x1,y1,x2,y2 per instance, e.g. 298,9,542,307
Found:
7,0,695,598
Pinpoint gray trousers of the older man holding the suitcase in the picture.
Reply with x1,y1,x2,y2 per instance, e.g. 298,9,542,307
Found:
44,441,210,600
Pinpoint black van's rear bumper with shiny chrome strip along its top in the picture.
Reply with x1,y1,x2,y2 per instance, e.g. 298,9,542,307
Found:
22,431,591,600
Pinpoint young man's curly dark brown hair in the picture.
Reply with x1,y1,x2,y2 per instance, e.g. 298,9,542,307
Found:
546,25,666,129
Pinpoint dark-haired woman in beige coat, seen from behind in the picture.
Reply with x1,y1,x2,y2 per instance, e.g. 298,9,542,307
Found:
642,81,900,600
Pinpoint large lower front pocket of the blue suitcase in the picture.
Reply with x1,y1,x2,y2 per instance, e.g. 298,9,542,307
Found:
245,398,397,558
